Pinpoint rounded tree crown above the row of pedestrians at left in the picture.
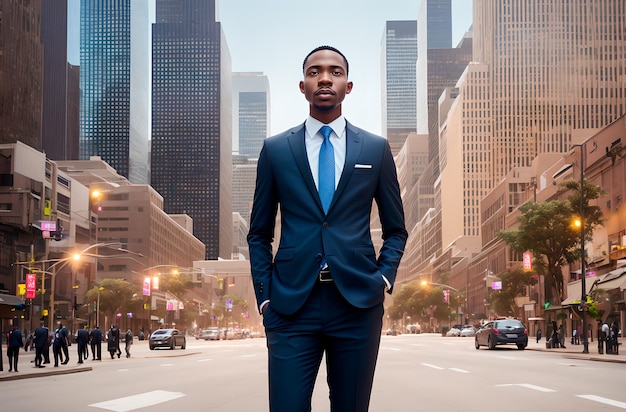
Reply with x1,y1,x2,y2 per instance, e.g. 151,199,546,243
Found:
85,279,143,326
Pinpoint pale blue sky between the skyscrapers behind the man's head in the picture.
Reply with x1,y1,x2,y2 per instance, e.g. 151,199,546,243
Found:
68,0,472,138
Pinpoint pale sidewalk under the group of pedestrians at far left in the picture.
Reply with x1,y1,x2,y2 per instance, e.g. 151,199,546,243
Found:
0,345,92,382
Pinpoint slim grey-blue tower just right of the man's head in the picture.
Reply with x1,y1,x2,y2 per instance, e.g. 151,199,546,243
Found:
381,20,417,155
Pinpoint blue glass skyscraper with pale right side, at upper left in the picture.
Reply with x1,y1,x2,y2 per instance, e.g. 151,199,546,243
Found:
79,0,150,183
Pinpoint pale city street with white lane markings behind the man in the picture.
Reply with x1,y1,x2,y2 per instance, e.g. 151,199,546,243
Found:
0,334,626,412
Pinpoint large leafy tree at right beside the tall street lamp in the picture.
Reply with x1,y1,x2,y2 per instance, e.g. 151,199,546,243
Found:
498,181,603,302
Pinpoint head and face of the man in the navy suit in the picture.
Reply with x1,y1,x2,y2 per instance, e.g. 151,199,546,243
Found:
300,50,352,121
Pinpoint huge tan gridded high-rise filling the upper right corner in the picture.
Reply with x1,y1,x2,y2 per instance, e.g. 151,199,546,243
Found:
466,0,626,185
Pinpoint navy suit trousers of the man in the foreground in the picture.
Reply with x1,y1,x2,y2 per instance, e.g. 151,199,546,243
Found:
263,282,384,412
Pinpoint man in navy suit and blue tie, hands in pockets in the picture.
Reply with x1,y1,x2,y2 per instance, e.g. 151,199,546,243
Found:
248,46,407,412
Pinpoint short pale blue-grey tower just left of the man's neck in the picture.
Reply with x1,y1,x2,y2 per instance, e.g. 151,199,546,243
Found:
233,72,270,159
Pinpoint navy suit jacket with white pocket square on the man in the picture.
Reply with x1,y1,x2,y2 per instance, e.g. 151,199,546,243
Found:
248,122,407,315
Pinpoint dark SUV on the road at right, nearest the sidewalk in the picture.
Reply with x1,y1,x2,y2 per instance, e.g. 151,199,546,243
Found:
474,319,528,350
